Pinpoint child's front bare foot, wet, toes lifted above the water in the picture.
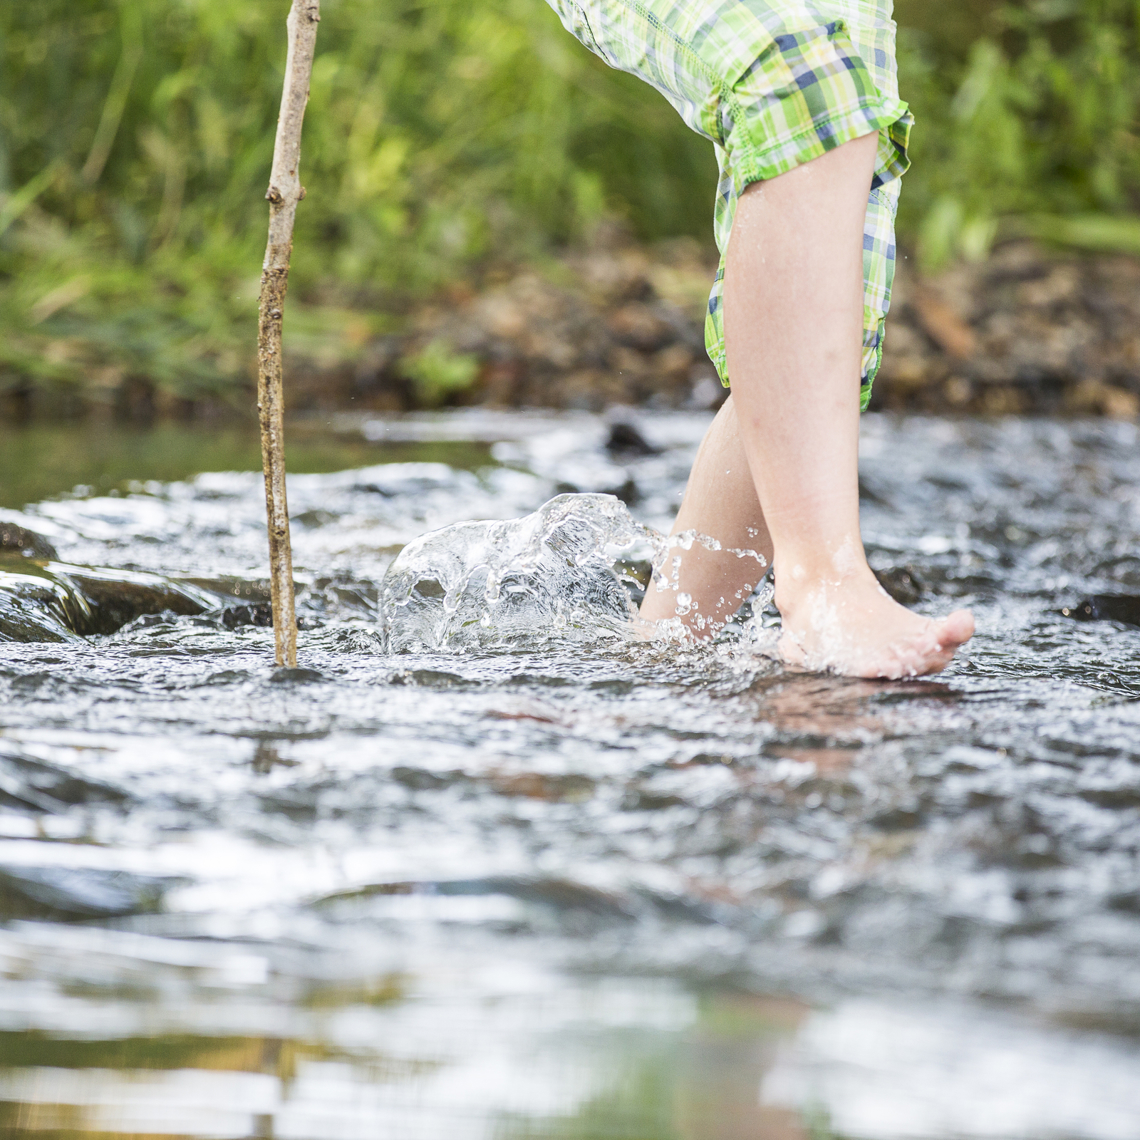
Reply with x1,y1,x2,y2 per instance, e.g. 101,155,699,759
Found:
776,570,974,679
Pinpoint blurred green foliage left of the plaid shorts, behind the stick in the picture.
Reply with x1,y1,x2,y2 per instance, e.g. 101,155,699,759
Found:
0,0,715,400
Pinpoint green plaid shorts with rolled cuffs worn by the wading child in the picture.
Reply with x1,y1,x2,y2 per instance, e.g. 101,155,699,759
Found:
548,0,913,408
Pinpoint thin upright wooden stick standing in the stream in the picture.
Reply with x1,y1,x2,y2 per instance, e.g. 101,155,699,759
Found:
258,0,320,666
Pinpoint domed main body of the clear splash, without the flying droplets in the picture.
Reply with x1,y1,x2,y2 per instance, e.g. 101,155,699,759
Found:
380,495,650,653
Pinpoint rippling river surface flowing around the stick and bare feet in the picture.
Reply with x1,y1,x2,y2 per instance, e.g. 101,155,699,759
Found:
0,412,1140,1140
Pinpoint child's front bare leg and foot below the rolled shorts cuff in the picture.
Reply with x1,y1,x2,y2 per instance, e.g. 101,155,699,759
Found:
645,135,974,677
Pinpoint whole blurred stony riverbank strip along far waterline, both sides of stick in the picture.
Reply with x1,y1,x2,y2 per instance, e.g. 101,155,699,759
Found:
8,234,1140,423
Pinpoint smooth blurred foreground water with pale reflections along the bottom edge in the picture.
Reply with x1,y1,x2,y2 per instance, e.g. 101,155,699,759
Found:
0,966,1140,1140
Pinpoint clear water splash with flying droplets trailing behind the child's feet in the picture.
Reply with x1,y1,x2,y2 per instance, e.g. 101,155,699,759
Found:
381,494,772,653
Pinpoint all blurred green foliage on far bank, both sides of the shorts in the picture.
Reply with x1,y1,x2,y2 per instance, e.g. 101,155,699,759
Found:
0,0,1140,402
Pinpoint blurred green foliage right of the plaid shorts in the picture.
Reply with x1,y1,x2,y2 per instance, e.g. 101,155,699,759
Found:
896,0,1140,269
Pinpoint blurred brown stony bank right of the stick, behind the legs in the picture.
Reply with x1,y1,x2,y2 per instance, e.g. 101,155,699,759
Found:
245,243,1140,418
